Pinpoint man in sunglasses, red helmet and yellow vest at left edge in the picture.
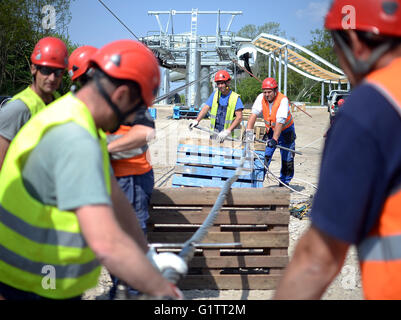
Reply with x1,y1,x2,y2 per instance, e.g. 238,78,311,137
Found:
0,37,68,169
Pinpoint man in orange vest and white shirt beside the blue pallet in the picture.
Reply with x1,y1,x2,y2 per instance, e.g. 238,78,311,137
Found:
245,78,296,187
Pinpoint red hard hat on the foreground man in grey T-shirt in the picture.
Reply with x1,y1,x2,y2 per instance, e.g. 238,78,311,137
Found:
89,40,160,106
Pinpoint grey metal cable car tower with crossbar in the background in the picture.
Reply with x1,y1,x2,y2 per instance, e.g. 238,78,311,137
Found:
141,9,252,107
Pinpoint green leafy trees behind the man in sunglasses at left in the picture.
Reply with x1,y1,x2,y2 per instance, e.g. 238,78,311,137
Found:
0,0,76,95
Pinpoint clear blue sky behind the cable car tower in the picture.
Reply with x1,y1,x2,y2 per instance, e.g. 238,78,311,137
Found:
69,0,330,47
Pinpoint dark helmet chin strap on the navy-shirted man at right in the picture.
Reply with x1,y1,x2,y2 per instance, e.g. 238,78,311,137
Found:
332,31,394,76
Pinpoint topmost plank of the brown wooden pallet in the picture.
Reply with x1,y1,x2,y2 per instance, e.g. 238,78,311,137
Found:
150,188,290,206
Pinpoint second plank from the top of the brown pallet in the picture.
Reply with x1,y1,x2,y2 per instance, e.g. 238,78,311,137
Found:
149,208,290,225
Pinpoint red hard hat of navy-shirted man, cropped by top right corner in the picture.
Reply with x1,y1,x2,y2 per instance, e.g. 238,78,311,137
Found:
325,0,401,37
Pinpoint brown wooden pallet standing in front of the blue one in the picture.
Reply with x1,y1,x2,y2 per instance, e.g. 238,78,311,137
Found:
148,188,290,290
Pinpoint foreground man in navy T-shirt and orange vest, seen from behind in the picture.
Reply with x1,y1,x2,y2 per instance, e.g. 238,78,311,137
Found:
275,0,401,300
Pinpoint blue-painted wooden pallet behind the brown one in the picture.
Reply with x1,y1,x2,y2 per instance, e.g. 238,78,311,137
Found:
172,140,264,188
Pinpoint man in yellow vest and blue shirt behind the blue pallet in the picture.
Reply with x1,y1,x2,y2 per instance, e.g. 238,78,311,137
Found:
189,70,244,142
